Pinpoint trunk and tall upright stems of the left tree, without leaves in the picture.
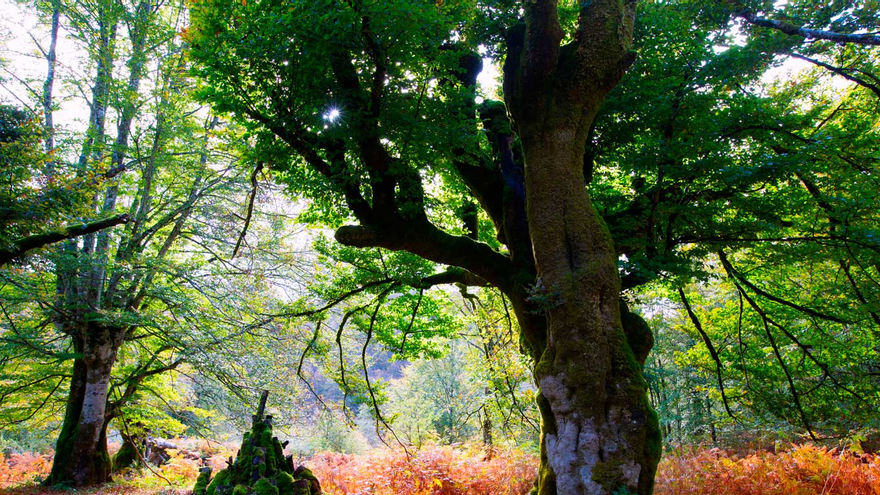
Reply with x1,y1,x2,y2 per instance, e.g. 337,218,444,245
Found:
45,0,151,486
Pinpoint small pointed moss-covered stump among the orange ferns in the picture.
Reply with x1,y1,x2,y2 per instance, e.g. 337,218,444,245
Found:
193,415,321,495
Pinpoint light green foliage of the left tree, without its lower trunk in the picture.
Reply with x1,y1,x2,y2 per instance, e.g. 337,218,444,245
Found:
0,2,314,472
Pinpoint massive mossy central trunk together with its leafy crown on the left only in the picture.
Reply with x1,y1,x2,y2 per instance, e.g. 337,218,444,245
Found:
187,0,660,494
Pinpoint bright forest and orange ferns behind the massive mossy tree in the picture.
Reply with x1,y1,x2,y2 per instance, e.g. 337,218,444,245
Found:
0,0,880,493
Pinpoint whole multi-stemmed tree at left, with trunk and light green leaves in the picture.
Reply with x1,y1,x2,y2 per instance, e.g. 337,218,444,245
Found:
0,0,294,486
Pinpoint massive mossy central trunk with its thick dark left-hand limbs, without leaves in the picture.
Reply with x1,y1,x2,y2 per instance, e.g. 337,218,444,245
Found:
194,0,660,495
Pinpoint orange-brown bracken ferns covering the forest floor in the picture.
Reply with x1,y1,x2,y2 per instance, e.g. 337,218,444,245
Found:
0,445,880,495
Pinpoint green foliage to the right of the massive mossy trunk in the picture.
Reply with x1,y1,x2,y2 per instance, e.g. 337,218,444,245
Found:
590,2,880,442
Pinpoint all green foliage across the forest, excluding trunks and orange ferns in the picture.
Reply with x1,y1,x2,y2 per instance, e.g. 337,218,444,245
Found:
0,0,880,495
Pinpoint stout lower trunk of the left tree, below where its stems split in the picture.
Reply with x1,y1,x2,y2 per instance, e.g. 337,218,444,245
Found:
44,327,123,486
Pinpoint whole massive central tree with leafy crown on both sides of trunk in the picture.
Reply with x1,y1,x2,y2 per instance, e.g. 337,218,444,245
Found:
185,0,876,495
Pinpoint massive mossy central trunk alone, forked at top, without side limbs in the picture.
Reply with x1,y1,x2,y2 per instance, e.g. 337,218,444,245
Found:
504,0,660,495
